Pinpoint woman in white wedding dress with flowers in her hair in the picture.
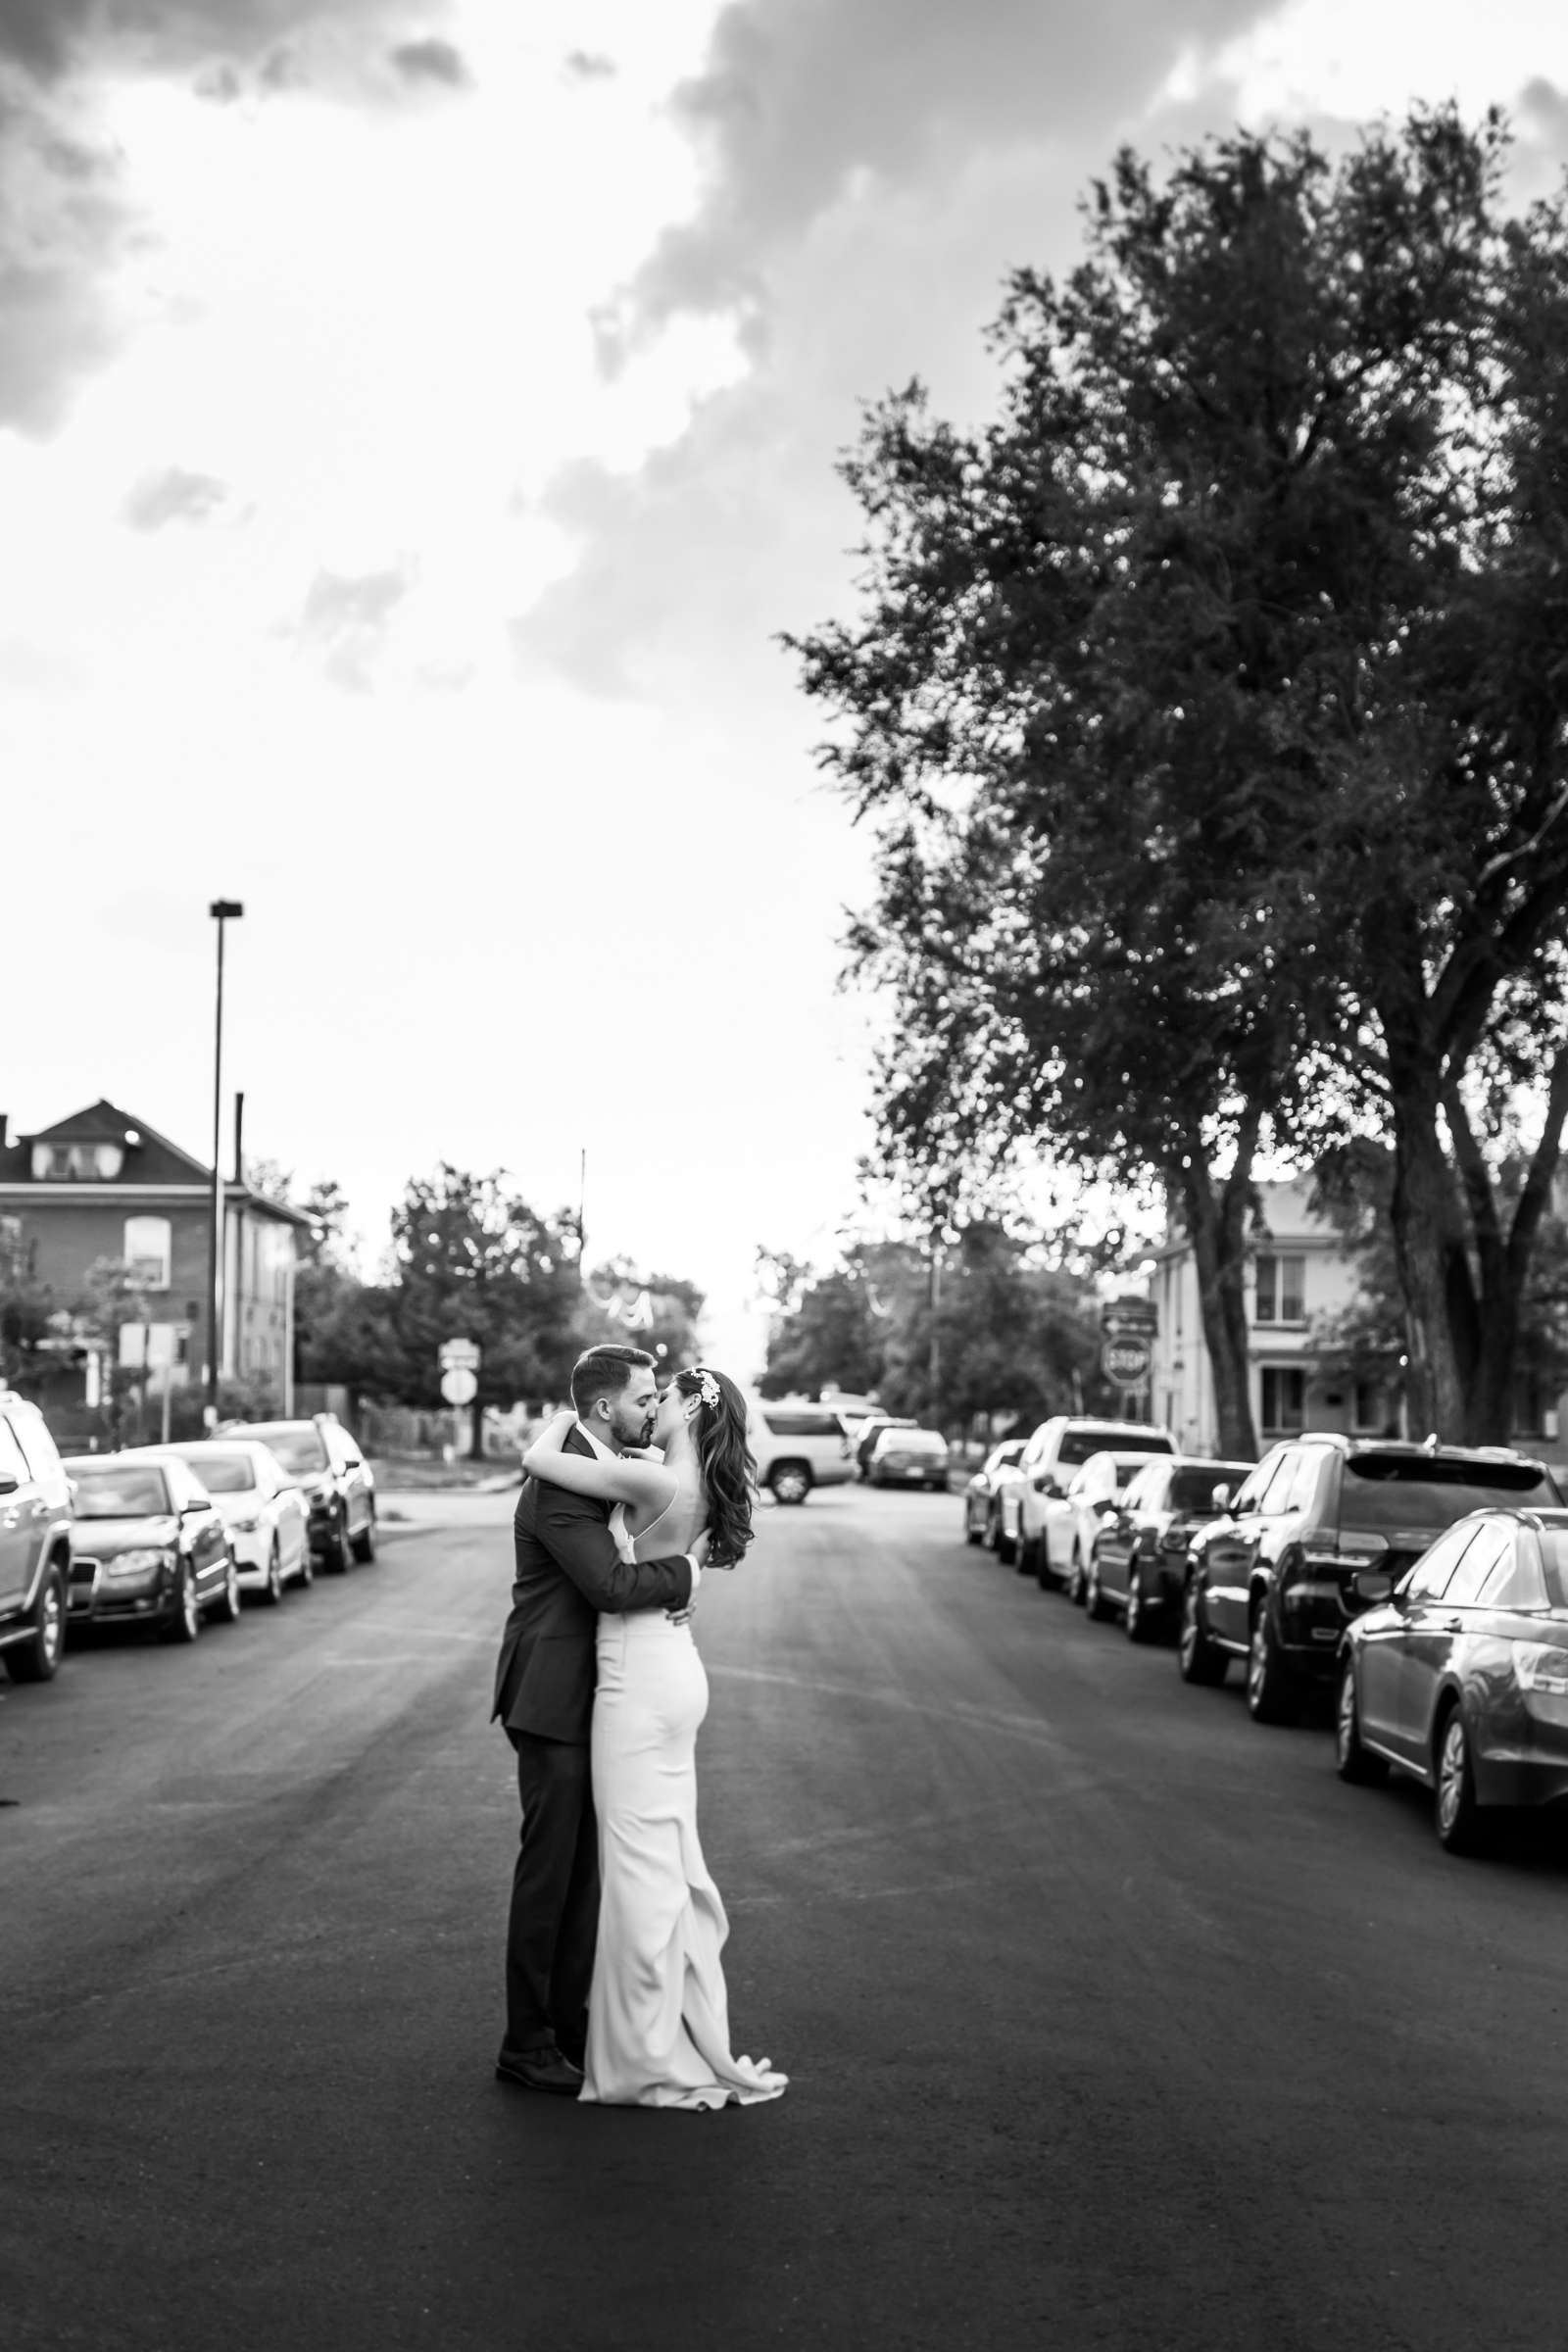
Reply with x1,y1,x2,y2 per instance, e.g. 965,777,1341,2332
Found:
522,1364,788,2107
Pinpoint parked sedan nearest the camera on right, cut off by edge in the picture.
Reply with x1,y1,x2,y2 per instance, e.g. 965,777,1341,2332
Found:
1336,1507,1568,1853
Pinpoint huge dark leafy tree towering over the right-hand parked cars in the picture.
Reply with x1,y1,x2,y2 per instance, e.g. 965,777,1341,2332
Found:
792,111,1568,1451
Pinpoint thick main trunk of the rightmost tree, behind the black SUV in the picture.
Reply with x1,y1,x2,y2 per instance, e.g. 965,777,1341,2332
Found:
1390,1072,1479,1445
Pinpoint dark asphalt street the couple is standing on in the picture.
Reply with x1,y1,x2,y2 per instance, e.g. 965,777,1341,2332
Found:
0,1489,1568,2352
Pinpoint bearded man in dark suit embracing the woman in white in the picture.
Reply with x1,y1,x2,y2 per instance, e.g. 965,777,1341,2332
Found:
491,1348,708,2098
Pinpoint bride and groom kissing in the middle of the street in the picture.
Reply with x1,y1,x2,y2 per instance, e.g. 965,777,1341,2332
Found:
494,1346,788,2107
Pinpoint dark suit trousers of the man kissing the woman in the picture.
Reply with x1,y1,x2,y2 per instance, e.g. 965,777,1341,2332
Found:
506,1731,600,2065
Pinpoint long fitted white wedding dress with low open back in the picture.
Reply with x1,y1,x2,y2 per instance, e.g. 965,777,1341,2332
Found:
578,1507,788,2107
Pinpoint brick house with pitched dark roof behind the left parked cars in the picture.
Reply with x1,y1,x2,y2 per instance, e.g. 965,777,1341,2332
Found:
0,1103,311,1411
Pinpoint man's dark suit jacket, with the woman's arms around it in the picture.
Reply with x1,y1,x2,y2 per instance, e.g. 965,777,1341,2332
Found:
491,1430,691,1747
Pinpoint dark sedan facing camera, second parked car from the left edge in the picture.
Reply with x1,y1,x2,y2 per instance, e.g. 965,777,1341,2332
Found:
66,1446,240,1642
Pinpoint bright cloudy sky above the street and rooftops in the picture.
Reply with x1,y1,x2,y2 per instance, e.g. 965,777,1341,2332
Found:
0,0,1568,1369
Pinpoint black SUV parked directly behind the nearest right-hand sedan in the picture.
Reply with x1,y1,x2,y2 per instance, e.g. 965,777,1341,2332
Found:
1178,1433,1561,1724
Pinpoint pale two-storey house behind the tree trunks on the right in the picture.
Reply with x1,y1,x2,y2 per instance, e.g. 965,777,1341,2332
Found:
1152,1178,1558,1453
